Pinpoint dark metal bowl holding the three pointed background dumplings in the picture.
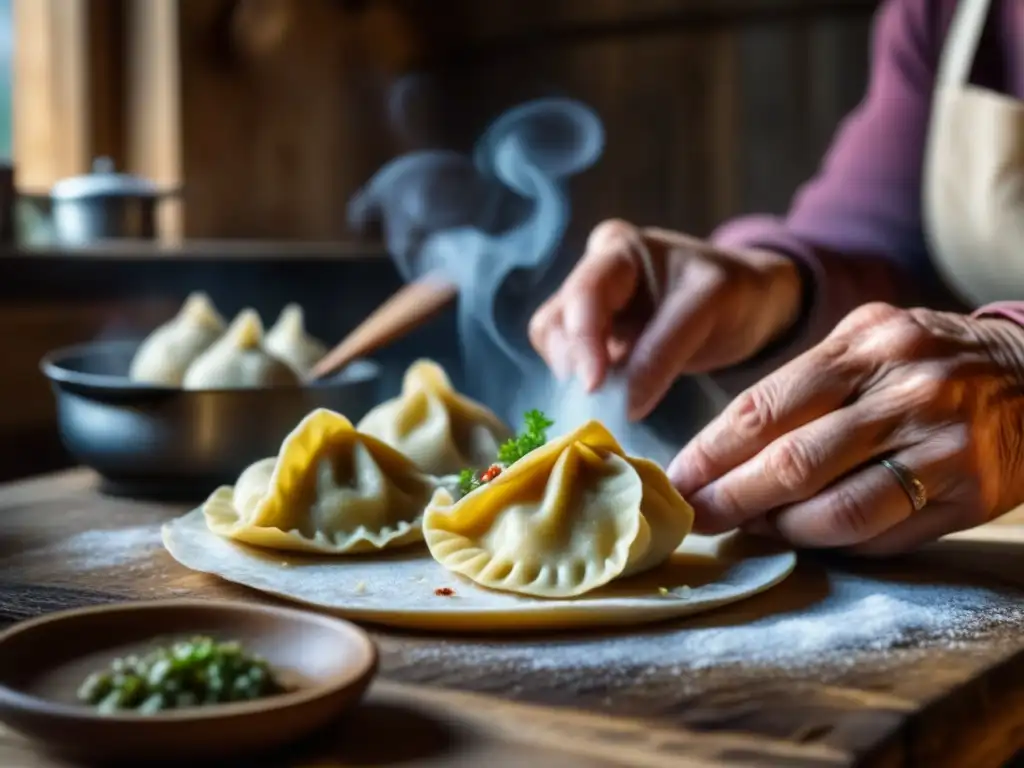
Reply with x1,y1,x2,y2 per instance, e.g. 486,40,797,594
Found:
40,341,380,498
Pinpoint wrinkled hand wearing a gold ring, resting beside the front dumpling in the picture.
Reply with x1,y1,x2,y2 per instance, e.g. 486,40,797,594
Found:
669,304,1024,554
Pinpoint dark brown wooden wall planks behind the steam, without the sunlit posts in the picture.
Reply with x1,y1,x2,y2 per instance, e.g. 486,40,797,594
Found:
165,0,873,240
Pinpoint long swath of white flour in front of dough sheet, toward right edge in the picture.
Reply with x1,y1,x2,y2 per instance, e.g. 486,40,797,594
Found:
393,572,1024,676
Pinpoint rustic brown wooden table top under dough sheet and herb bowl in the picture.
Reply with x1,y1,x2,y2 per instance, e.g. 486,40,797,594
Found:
0,470,1024,768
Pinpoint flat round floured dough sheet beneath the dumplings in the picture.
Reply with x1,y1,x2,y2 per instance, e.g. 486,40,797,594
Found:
163,510,797,633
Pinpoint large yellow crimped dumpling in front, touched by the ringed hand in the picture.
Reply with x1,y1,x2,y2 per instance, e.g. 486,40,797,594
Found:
423,421,693,598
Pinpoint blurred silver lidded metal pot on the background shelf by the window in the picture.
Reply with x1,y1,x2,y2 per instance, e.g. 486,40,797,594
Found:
39,158,178,246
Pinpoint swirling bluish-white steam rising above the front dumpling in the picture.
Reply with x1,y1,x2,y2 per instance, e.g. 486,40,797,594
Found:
349,99,674,463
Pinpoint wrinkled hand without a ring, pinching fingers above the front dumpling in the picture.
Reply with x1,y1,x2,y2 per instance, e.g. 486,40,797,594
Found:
529,220,801,419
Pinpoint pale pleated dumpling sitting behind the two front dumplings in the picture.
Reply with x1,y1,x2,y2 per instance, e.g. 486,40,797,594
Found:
358,360,512,475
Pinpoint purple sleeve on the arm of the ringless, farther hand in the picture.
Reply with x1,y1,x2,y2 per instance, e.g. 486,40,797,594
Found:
712,0,951,390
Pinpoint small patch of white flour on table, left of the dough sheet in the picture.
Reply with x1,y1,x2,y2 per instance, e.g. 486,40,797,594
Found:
5,525,163,572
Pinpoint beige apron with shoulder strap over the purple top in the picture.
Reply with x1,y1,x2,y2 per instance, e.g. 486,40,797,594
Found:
923,0,1024,305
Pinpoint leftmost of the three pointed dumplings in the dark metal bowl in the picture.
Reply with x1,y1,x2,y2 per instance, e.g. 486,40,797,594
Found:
128,292,224,387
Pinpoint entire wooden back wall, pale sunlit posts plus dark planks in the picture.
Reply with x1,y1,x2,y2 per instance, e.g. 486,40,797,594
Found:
8,0,876,241
